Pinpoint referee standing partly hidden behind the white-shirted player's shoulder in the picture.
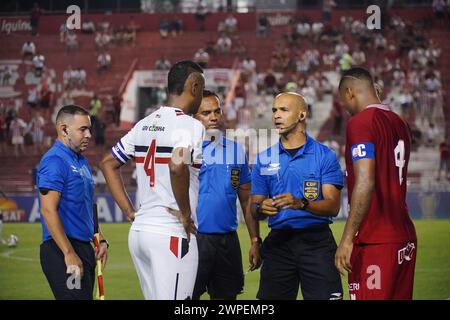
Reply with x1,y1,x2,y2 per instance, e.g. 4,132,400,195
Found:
193,90,261,300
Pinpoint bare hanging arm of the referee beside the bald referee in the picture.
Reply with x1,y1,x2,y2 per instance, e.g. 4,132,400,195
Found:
238,182,261,271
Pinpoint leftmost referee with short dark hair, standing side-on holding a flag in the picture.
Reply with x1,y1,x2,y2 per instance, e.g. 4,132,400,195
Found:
37,105,108,300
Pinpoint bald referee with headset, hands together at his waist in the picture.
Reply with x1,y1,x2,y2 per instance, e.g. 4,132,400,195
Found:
252,92,343,300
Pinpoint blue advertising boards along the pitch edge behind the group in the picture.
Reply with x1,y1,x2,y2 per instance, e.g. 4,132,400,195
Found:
0,192,450,223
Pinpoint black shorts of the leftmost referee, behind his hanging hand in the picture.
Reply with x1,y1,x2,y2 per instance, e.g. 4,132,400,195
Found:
40,239,95,300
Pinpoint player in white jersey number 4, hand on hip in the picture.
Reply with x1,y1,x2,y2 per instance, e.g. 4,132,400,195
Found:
100,61,205,300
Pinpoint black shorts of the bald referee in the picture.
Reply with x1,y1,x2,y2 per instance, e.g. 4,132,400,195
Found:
257,225,343,300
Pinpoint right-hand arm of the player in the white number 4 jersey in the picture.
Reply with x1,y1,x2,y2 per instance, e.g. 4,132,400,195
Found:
169,148,197,242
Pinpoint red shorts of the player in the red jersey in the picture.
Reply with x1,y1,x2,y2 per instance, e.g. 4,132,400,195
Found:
348,241,417,300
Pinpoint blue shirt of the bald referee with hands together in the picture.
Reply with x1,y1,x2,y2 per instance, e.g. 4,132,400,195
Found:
252,135,344,229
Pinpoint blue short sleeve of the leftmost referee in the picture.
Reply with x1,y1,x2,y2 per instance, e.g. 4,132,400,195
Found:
37,156,67,193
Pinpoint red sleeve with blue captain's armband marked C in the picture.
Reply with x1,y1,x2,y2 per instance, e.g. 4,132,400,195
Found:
347,113,376,162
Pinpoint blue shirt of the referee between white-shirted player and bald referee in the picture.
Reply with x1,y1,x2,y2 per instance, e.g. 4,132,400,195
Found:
197,137,251,233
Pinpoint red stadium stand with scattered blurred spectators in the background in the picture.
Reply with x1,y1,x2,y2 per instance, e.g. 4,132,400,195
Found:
0,8,450,193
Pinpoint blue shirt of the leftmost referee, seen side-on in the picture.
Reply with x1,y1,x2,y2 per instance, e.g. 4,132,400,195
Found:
37,140,94,241
